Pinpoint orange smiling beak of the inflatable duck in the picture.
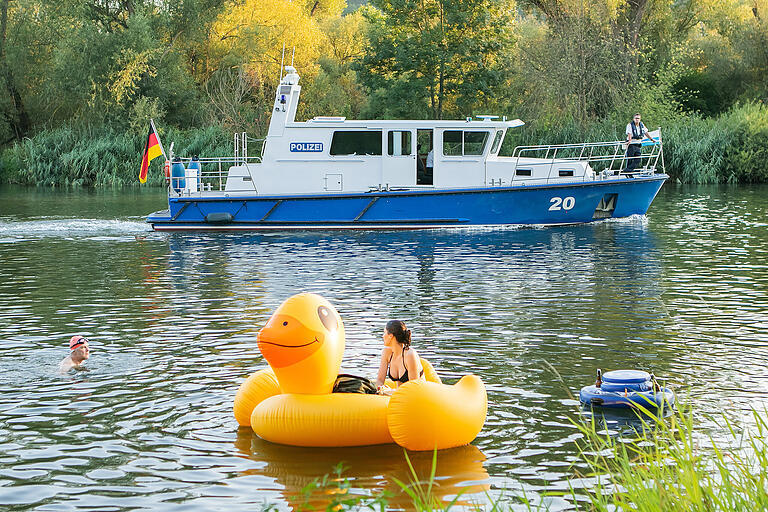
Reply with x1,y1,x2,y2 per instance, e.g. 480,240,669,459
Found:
256,314,325,368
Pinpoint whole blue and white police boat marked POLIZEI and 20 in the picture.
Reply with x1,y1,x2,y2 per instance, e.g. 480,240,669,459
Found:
147,66,668,230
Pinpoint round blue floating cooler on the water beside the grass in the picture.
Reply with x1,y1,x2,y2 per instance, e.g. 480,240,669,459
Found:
579,370,675,410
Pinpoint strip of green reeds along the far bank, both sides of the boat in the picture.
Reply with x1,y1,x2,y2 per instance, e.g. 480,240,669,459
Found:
0,103,768,188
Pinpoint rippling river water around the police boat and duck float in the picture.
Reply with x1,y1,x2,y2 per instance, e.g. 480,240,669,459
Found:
0,184,768,511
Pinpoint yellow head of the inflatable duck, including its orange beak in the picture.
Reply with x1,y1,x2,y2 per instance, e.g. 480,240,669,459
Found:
257,293,344,395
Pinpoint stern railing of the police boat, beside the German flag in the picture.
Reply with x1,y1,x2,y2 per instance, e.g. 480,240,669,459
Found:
168,154,261,197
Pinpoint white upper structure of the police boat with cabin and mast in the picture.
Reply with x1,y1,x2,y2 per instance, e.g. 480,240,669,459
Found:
176,66,660,196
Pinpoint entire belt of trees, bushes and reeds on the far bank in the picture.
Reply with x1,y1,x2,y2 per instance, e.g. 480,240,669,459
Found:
0,0,768,187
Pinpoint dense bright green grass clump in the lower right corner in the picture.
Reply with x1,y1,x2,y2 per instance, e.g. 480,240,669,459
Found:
579,411,768,512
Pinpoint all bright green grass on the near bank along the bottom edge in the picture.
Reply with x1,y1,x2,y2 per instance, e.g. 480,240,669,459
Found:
300,410,768,512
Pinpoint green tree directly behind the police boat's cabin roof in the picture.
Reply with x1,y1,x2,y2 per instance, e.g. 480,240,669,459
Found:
357,0,514,119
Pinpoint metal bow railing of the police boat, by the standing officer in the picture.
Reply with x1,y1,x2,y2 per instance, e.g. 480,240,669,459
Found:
512,136,664,182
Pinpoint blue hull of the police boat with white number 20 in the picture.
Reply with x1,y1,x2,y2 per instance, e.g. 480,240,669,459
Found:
147,174,668,231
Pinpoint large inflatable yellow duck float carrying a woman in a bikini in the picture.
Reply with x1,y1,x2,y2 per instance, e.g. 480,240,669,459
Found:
234,293,488,451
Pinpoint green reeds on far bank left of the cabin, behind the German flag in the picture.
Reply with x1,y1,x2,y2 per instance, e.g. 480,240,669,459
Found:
0,126,232,187
